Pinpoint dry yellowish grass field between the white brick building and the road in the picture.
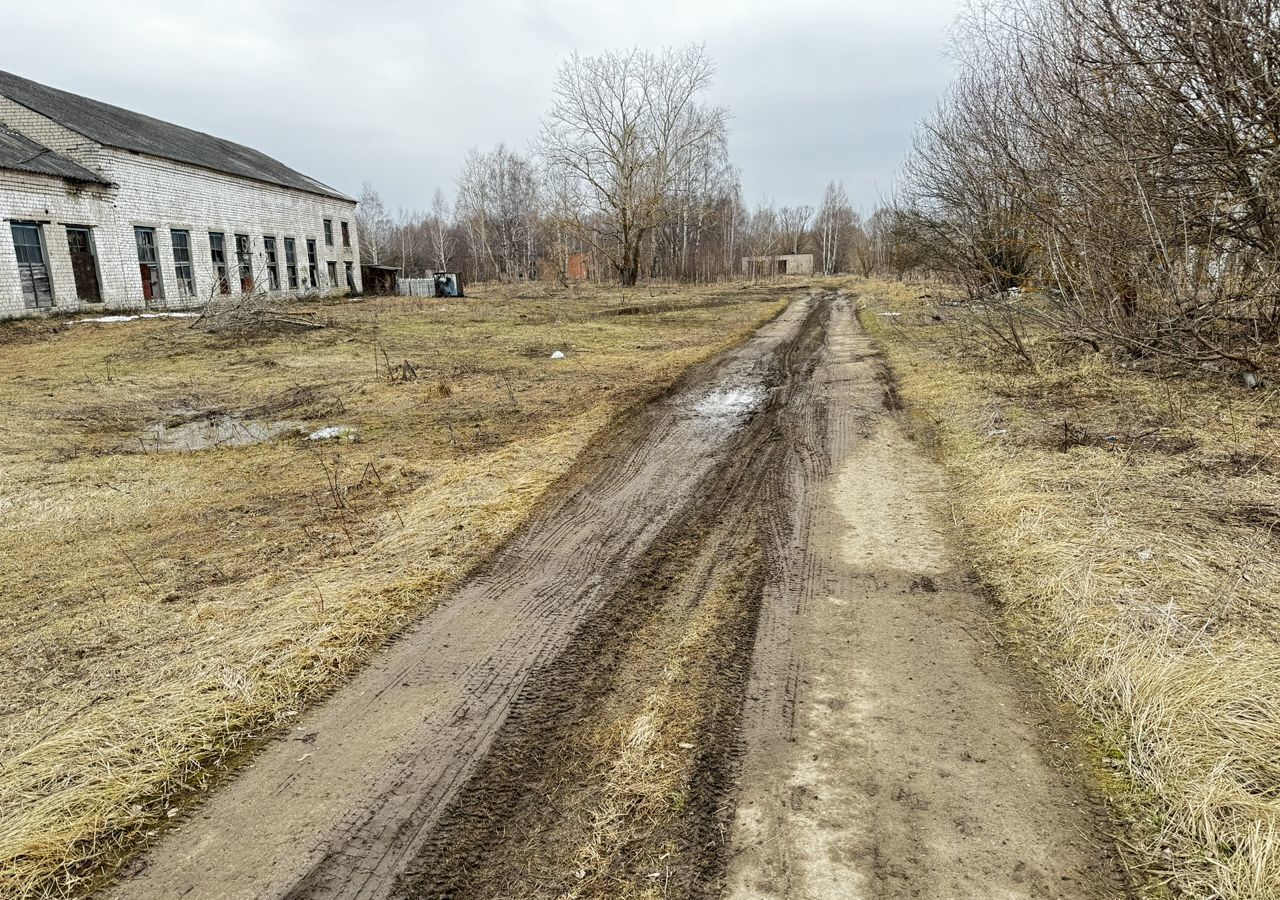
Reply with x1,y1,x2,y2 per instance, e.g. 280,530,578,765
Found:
0,285,782,897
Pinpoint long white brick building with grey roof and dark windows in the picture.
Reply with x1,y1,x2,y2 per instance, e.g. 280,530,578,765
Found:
0,72,360,319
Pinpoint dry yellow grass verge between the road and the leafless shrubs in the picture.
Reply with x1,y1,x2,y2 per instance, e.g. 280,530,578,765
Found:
850,282,1280,900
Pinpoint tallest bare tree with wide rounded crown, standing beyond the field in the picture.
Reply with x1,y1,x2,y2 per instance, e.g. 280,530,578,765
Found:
538,46,728,284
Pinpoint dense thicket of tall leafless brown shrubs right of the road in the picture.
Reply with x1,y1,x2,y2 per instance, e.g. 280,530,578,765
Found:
905,0,1280,380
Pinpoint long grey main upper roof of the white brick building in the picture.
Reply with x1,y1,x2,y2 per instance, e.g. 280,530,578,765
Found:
0,72,355,202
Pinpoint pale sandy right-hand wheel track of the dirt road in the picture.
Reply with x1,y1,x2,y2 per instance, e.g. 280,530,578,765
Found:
724,300,1124,900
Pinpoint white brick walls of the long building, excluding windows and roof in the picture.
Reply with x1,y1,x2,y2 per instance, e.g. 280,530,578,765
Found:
0,96,360,319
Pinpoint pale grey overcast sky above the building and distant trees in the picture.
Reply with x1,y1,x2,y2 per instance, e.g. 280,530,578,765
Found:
0,0,960,209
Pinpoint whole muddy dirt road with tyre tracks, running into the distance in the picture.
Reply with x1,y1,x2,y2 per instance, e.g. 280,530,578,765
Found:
108,296,1123,900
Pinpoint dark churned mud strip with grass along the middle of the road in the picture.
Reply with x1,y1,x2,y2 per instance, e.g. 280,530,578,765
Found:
396,302,829,899
